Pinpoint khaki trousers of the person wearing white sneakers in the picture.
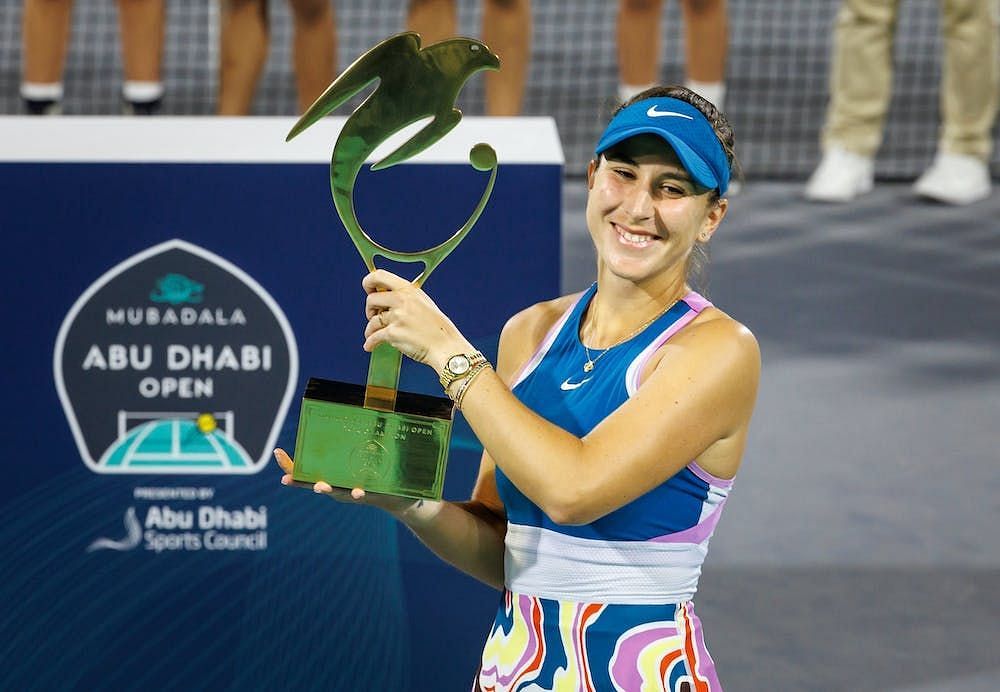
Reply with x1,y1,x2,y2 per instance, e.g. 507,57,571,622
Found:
823,0,1000,161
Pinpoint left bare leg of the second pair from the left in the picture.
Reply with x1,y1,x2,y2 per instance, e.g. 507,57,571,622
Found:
218,0,268,115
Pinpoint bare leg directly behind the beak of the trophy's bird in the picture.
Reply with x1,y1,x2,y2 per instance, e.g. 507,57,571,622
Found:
483,0,531,115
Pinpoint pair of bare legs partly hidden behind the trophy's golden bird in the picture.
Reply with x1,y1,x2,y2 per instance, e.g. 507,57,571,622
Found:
406,0,531,115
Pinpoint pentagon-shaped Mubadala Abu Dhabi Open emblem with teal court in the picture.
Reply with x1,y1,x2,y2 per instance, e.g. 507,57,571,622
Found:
53,240,298,474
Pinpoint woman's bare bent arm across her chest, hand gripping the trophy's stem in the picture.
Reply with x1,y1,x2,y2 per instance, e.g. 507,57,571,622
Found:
364,270,760,524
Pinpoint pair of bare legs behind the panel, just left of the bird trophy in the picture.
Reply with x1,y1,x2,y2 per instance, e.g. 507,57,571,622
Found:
217,0,337,115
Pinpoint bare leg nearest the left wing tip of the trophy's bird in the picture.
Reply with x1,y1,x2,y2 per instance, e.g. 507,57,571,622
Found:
289,0,337,113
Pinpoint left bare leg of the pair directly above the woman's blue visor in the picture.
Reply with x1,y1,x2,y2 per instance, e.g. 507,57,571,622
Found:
617,0,663,101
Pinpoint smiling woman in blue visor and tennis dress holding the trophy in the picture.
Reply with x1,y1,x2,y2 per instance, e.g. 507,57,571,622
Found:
276,87,760,691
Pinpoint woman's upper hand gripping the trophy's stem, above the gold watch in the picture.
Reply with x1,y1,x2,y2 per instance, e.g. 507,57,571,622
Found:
361,269,474,373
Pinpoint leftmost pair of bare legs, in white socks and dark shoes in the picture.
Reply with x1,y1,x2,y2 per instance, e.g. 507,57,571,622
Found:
21,0,165,115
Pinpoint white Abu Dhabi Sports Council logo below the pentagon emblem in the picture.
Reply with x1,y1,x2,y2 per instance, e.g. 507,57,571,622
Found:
87,504,267,553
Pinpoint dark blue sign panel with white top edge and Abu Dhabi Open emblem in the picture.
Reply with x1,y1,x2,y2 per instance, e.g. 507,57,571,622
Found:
0,118,562,692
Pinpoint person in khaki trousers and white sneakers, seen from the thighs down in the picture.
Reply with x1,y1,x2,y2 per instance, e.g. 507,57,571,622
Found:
805,0,1000,204
